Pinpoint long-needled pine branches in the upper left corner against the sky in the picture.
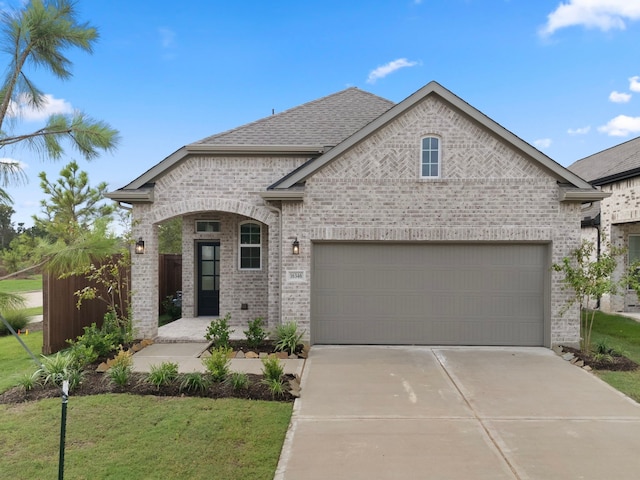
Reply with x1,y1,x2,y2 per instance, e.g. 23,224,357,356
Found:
0,0,118,163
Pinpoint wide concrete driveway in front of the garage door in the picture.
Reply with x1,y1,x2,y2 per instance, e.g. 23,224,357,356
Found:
275,346,640,480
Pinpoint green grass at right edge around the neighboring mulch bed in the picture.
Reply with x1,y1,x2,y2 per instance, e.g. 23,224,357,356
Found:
591,312,640,402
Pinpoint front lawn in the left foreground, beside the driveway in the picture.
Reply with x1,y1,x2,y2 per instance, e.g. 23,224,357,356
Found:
0,395,292,480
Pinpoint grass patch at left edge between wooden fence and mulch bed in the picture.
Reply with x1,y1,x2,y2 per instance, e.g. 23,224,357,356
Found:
0,331,42,392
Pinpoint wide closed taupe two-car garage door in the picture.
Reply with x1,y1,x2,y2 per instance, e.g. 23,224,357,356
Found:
311,243,549,346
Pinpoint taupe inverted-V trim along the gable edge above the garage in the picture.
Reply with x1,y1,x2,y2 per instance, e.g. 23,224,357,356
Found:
269,81,592,190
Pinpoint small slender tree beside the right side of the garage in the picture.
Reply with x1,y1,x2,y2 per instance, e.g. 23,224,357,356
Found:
553,240,624,353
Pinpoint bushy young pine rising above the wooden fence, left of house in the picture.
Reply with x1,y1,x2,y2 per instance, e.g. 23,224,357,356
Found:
33,162,115,244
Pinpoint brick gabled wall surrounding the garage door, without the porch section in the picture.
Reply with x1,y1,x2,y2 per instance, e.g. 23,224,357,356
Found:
282,98,580,344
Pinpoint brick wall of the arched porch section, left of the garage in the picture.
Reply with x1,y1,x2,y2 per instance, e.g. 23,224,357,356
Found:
132,156,308,337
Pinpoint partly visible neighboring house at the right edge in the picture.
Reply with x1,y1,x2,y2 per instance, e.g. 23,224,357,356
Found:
569,137,640,312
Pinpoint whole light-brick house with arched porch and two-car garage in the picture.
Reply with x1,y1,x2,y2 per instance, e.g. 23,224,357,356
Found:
109,82,603,346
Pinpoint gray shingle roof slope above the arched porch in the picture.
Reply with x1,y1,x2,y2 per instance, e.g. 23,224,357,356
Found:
193,87,394,147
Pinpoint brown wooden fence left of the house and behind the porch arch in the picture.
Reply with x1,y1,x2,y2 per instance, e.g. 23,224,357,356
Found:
42,255,182,355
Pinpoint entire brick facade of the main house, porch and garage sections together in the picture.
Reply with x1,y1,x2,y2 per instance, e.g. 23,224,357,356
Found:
127,92,580,344
